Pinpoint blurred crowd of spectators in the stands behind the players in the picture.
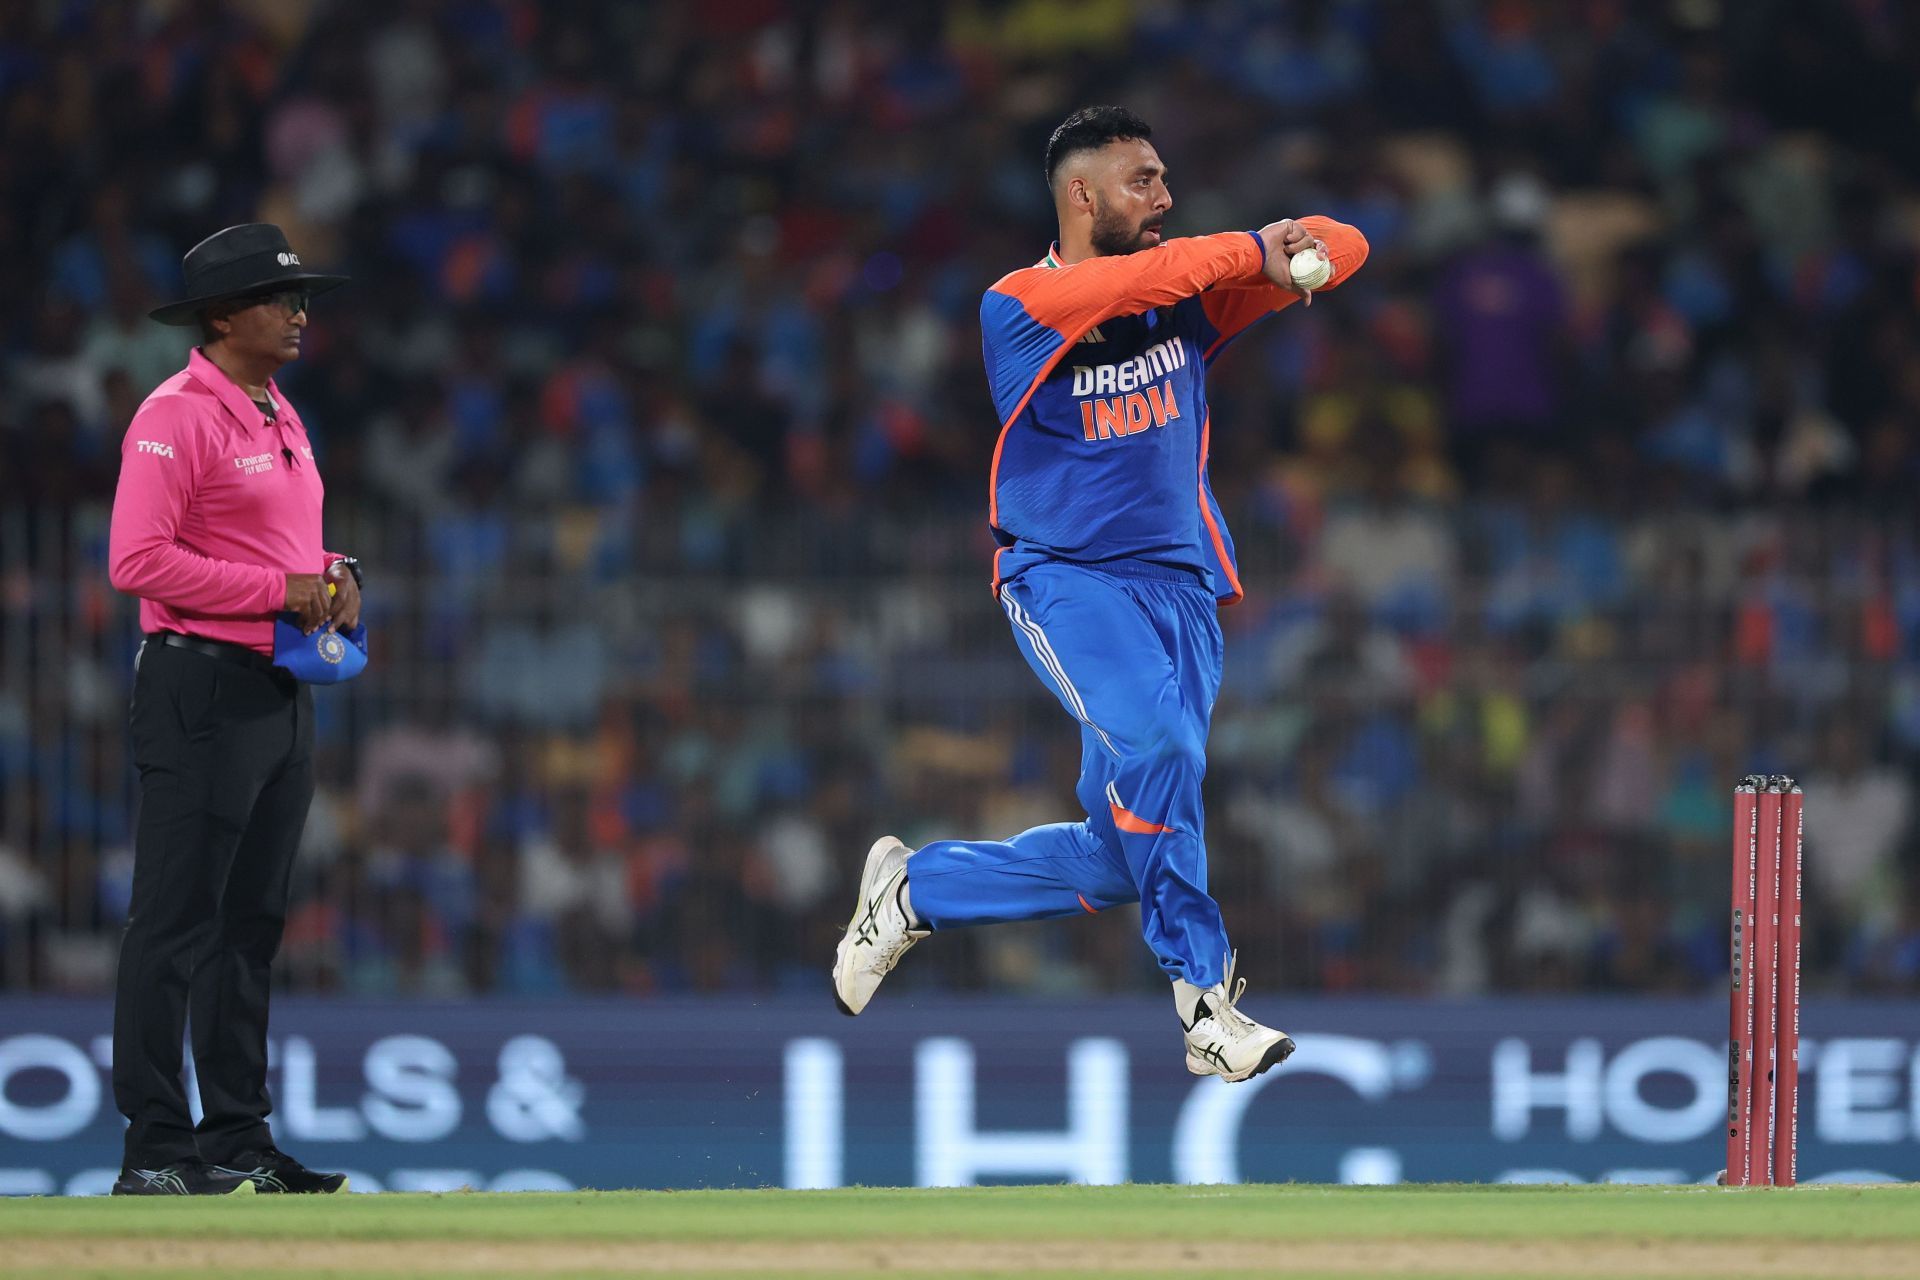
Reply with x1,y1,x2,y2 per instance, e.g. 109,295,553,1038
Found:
0,0,1920,994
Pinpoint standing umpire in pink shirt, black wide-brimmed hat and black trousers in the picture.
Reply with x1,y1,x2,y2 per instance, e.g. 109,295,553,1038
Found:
109,223,361,1196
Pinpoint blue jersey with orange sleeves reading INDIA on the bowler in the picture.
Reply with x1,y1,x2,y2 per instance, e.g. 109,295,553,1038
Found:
979,217,1367,604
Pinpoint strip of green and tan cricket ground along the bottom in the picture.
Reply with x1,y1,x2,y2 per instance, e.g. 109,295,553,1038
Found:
0,1184,1920,1280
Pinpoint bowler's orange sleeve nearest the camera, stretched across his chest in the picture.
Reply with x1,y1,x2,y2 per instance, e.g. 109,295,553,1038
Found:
993,230,1265,344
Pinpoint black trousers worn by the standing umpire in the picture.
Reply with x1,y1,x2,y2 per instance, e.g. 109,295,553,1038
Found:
113,641,313,1169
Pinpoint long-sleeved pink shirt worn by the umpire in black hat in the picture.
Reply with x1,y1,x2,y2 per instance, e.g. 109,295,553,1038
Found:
108,347,340,654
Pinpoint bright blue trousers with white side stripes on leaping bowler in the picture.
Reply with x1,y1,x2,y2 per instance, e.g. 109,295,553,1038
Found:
906,562,1227,986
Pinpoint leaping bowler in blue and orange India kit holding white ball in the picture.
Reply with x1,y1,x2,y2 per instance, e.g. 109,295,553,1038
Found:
833,106,1367,1080
